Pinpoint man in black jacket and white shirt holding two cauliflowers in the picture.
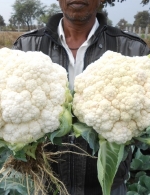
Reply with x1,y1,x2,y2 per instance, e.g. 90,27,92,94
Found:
14,0,149,195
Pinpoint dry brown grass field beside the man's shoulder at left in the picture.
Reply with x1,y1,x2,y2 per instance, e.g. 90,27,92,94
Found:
0,31,23,48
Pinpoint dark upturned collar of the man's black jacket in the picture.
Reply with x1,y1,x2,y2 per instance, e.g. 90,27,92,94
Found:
45,13,107,43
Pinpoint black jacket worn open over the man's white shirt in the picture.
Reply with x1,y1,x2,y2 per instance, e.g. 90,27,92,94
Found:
14,14,150,195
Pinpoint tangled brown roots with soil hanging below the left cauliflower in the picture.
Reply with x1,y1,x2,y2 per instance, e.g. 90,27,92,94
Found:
0,143,69,195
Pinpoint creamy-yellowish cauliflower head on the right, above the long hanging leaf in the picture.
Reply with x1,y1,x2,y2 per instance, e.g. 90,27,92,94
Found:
73,51,150,144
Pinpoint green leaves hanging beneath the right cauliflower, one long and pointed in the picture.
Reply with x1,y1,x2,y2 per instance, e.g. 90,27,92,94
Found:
73,122,125,195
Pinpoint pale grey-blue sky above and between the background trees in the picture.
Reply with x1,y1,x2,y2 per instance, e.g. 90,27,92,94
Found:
0,0,150,26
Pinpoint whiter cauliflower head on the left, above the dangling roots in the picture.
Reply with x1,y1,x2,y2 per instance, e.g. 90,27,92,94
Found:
0,48,71,144
